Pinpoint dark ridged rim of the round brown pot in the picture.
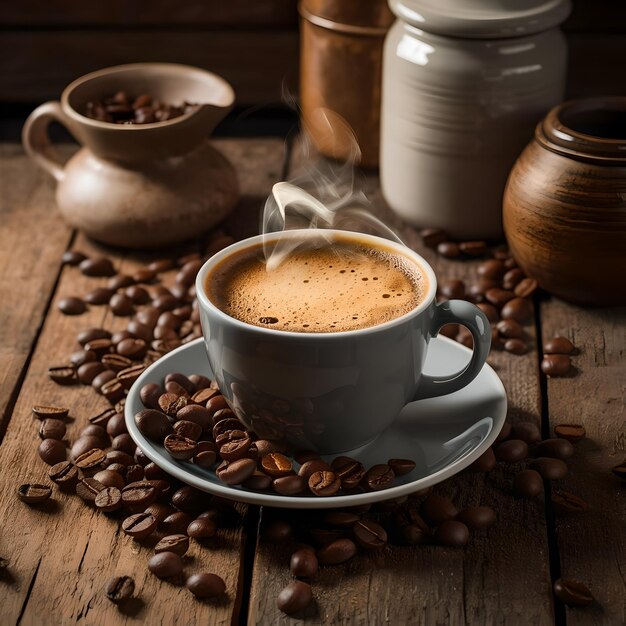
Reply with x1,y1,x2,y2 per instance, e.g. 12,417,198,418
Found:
535,96,626,165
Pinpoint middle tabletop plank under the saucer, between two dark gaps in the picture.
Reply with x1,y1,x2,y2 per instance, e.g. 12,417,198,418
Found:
249,143,553,625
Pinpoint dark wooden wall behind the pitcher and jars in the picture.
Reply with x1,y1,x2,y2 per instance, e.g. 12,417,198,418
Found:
0,0,626,140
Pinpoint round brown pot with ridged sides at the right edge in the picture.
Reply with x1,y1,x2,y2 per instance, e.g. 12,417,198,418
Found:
503,97,626,306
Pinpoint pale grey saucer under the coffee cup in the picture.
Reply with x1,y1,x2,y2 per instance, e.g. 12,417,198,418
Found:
126,337,507,509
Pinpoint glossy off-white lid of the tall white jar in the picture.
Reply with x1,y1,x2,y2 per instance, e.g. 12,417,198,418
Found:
389,0,572,39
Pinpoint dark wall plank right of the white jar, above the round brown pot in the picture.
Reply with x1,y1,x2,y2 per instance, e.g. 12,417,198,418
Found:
566,33,626,98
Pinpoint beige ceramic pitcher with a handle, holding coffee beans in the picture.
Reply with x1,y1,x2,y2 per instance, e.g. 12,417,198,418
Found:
22,63,238,248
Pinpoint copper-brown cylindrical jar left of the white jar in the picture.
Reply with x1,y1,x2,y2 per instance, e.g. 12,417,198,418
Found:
299,0,394,167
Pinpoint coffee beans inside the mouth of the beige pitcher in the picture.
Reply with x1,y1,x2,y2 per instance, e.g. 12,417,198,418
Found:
84,91,198,124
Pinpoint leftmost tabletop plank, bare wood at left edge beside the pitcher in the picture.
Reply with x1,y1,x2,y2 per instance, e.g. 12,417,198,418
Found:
0,144,71,440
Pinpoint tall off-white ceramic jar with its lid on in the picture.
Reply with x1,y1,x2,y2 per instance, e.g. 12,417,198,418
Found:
380,0,571,239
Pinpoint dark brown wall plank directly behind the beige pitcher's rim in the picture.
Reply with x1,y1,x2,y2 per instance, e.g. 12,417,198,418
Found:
0,29,298,105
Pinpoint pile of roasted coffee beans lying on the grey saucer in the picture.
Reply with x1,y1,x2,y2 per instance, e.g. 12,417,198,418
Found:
135,372,415,497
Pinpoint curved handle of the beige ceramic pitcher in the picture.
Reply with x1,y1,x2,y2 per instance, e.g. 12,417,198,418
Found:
22,101,68,182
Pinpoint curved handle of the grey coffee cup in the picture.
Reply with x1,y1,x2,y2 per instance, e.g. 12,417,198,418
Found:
414,300,491,400
